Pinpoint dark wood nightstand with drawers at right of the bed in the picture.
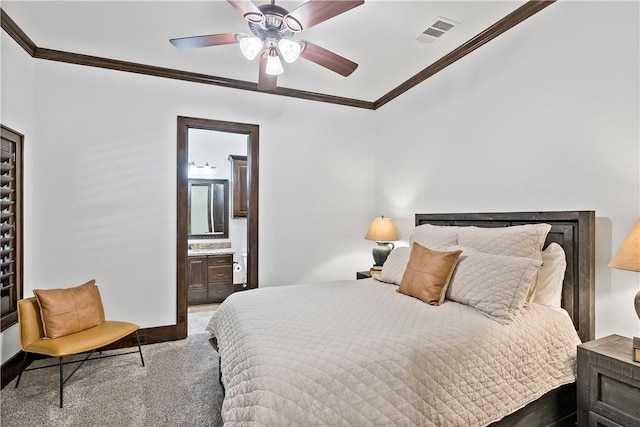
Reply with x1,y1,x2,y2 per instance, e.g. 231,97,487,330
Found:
577,335,640,426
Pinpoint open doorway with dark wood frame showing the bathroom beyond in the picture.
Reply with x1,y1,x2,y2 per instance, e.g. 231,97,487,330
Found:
176,117,259,339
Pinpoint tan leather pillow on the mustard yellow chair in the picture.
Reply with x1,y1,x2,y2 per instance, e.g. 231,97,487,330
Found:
33,280,104,338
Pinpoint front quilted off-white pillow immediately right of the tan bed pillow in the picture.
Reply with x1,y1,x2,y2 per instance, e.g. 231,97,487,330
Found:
446,246,542,323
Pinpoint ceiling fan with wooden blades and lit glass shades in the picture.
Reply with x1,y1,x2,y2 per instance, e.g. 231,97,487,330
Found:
169,0,364,90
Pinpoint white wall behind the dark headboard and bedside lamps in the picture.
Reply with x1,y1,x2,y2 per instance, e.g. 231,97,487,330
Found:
375,2,640,342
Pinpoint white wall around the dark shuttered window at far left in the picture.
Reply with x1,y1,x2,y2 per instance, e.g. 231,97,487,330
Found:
0,31,37,363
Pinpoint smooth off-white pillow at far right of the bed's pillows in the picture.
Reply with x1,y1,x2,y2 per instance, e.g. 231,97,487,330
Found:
533,242,567,308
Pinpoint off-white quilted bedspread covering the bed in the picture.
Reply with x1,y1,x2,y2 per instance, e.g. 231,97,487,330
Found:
208,279,580,427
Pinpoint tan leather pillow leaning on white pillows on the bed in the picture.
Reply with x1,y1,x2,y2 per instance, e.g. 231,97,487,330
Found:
398,243,462,305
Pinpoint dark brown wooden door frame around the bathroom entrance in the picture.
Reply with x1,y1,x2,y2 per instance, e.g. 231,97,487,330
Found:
176,116,260,339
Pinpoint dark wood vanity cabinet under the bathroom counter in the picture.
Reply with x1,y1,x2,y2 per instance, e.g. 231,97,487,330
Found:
187,254,233,305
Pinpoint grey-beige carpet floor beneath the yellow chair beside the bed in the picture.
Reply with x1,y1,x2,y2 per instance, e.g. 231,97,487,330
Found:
0,333,223,427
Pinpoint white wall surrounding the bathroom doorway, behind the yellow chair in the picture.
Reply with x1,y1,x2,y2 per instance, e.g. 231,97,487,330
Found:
27,58,373,312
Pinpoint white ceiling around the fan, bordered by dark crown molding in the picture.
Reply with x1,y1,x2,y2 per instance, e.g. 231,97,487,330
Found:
1,0,526,101
